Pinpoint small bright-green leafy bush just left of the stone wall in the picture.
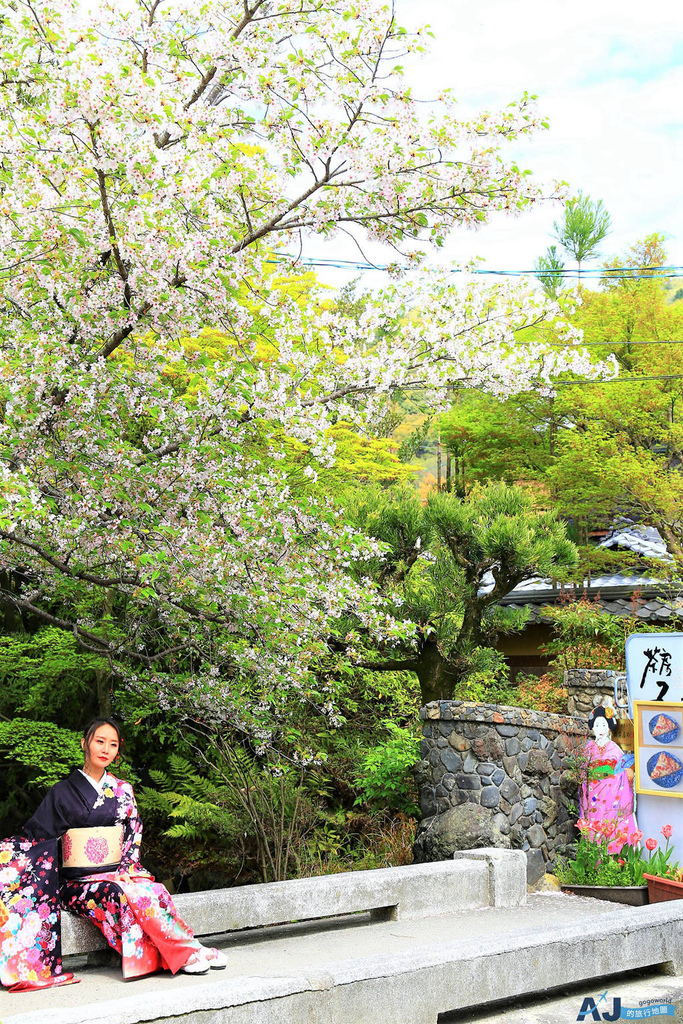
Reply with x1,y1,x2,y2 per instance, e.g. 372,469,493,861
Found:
355,721,420,815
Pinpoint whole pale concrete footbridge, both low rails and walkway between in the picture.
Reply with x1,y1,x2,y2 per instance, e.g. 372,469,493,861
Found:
7,850,683,1024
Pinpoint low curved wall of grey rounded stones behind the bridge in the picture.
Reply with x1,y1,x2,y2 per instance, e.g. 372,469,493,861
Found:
415,700,587,882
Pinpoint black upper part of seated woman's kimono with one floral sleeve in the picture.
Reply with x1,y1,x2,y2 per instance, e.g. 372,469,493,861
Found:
23,770,142,879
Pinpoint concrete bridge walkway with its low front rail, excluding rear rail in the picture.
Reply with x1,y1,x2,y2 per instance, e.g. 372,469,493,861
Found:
5,893,683,1024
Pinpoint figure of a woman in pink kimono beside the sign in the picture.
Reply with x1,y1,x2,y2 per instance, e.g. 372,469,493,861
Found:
580,706,638,853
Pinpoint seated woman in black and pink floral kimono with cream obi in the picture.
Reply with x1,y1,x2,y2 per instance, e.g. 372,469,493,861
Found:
0,719,226,990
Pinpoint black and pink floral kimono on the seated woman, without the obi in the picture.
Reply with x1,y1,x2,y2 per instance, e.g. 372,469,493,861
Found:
0,771,201,987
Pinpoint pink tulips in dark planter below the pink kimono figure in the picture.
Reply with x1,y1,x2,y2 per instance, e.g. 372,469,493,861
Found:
555,818,656,906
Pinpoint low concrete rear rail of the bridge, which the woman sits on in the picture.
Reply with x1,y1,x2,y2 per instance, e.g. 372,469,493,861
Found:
61,849,526,956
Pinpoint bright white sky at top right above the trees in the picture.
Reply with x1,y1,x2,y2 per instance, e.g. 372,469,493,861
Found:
316,0,683,287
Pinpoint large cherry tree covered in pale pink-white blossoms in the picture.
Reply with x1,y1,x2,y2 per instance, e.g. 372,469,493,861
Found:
0,0,611,735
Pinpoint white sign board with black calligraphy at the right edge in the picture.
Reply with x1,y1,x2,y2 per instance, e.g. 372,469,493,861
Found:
626,633,683,843
